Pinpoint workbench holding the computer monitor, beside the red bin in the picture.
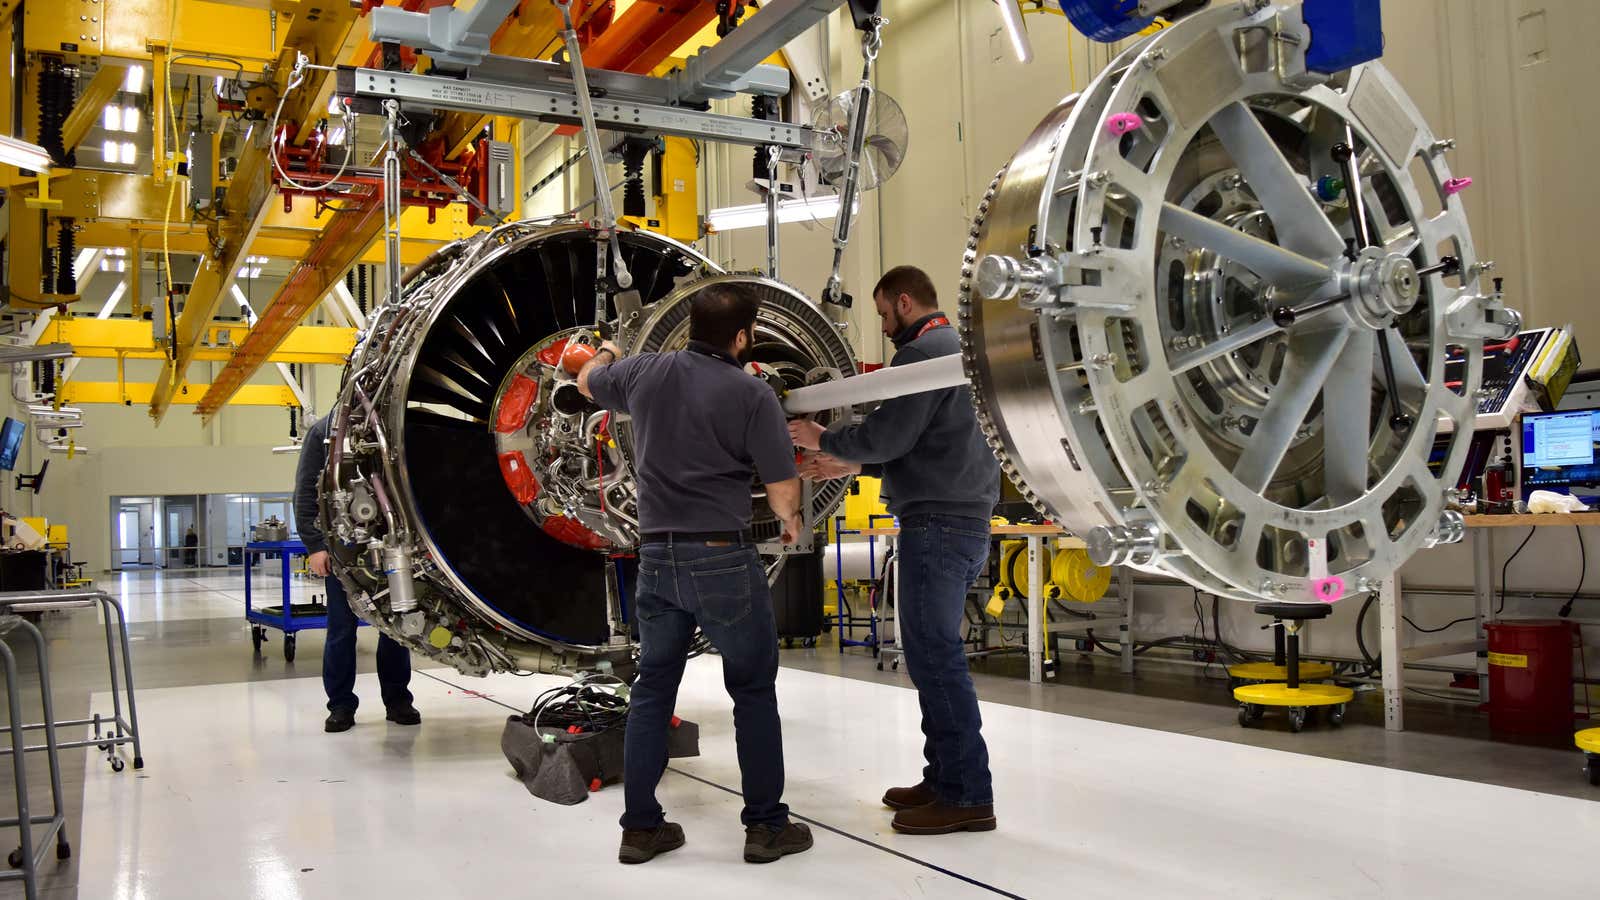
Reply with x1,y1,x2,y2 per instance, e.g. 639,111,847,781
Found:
1378,512,1600,732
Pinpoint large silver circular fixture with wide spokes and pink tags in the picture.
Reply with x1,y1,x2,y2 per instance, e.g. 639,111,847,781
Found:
960,5,1517,602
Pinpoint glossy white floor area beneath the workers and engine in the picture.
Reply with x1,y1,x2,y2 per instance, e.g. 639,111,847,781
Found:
77,658,1600,900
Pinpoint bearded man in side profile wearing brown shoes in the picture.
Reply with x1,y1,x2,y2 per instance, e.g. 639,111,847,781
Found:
789,266,1000,834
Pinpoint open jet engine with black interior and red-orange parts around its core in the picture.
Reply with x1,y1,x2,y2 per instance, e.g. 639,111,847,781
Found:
322,224,854,674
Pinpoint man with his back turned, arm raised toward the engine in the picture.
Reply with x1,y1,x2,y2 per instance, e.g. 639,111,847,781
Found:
576,285,811,863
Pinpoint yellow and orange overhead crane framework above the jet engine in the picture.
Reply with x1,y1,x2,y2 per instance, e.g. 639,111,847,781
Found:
0,0,777,423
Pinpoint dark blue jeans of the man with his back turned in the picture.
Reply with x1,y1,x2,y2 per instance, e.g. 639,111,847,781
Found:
621,541,789,828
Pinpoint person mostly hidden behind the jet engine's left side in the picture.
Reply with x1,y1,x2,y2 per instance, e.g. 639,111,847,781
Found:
294,416,422,732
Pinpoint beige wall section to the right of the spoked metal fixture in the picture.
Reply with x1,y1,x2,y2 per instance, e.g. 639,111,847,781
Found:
1384,0,1600,353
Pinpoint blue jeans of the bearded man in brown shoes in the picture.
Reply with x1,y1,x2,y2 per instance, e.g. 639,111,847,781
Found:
894,516,994,806
